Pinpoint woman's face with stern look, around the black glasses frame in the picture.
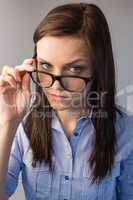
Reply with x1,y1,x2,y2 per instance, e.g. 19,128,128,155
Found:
37,36,92,110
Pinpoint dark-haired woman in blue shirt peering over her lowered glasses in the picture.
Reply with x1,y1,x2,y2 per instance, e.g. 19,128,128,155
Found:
0,3,133,200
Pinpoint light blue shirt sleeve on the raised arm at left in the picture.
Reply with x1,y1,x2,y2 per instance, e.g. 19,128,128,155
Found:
5,123,23,197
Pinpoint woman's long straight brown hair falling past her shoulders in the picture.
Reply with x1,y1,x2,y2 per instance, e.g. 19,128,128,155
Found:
25,2,120,181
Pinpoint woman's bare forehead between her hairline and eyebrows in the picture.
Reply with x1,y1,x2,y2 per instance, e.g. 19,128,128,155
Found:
37,36,89,60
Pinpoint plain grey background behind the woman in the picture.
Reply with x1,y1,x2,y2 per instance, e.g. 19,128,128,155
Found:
0,0,133,200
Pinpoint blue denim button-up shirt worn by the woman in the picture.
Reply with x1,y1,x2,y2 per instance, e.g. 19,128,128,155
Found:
5,108,133,200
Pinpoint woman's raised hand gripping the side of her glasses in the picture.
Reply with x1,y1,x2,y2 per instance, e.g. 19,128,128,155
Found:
0,58,35,124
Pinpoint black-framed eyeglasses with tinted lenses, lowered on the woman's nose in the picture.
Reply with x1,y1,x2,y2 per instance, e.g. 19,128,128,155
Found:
28,70,92,92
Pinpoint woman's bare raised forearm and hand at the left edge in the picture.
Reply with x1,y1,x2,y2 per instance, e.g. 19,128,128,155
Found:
0,59,34,198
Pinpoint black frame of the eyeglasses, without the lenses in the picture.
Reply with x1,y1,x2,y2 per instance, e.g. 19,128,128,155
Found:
28,70,93,92
